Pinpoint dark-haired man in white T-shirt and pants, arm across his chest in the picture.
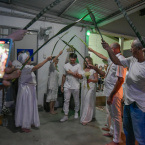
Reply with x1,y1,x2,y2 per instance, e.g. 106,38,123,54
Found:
60,53,82,122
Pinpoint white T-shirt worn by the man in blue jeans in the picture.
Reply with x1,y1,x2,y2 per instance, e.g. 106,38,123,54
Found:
120,57,145,112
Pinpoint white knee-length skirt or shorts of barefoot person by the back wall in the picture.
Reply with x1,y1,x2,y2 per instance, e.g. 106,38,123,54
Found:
46,89,58,102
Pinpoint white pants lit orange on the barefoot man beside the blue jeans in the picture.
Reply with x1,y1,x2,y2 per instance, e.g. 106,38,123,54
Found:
107,92,123,143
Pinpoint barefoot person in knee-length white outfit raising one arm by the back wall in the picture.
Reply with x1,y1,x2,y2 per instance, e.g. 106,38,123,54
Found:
46,50,63,114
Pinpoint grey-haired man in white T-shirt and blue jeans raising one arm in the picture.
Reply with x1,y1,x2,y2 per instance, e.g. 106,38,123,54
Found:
102,39,145,145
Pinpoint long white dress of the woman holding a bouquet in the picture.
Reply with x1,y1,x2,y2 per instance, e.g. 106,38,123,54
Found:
80,69,96,123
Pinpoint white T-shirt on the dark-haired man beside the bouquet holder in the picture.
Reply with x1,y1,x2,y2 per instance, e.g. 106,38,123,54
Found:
63,63,82,89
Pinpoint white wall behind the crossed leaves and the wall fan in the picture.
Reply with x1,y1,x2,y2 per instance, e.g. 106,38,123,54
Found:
0,16,85,105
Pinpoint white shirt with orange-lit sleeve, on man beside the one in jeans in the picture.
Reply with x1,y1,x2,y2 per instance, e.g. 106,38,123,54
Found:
104,53,126,97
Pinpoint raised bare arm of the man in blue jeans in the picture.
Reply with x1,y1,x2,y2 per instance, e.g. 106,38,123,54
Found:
102,41,122,66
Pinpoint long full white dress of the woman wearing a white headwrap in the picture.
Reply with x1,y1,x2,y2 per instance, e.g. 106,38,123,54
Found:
15,65,40,129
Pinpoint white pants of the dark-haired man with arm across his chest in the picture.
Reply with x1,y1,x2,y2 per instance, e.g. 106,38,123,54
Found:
63,88,80,115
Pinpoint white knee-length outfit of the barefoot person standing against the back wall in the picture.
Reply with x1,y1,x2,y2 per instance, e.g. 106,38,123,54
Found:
46,62,59,102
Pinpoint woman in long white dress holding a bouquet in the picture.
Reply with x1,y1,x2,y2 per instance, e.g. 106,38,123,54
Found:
80,56,98,125
